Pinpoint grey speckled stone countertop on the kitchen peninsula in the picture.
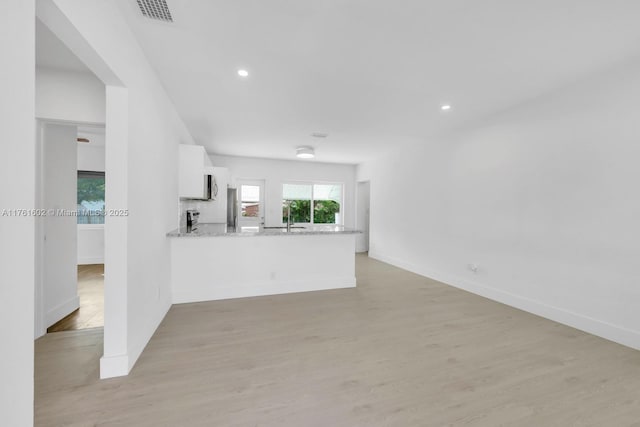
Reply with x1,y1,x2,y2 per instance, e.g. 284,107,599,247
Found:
167,223,362,237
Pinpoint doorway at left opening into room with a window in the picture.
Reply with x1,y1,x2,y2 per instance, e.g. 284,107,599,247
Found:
36,120,105,336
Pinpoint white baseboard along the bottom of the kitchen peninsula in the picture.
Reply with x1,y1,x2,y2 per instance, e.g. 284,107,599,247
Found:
172,277,356,304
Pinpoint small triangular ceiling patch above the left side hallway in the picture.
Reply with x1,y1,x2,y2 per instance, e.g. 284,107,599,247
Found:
36,19,90,73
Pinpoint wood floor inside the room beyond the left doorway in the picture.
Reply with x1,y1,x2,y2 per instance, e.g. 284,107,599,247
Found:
47,264,104,333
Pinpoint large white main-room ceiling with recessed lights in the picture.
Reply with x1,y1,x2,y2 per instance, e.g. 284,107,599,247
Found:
120,0,640,163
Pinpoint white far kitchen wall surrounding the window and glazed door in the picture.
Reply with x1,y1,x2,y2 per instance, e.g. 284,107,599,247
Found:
210,155,356,227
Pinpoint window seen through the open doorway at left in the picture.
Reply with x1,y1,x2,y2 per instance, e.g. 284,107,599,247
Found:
77,171,104,224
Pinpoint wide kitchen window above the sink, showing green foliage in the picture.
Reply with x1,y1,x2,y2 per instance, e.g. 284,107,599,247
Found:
282,184,342,224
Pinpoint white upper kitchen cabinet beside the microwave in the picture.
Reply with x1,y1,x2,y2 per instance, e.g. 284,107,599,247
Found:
178,144,213,199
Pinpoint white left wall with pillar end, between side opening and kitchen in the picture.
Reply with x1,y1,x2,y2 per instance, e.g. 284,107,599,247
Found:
38,0,193,377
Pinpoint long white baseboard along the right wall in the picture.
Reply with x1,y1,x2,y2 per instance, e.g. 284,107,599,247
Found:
369,251,640,350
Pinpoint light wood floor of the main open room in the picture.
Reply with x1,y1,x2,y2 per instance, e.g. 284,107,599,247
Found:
35,256,640,427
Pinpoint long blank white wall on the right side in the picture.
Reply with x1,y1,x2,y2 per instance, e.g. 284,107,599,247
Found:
359,56,640,349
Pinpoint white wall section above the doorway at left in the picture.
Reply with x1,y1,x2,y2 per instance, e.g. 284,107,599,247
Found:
36,67,105,123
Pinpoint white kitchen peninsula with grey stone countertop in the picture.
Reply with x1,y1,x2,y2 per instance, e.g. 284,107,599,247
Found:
167,224,359,303
